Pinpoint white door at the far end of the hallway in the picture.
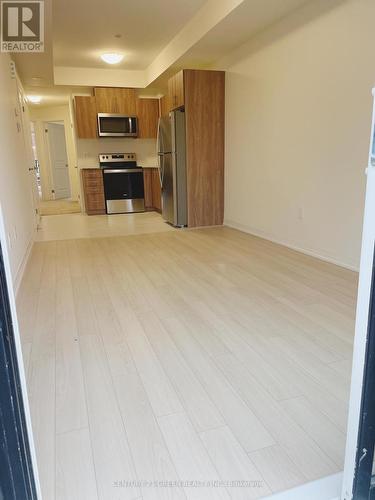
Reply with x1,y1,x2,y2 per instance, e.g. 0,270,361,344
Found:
47,123,71,199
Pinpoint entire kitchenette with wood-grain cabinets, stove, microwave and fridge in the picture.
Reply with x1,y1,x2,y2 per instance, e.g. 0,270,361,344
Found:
74,70,225,227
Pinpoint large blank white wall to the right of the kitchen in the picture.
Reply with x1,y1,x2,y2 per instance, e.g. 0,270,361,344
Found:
218,0,375,268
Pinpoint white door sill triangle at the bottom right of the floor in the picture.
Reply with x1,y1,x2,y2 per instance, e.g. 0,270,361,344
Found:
264,472,343,500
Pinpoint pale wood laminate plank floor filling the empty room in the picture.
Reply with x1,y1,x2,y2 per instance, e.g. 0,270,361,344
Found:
18,225,357,500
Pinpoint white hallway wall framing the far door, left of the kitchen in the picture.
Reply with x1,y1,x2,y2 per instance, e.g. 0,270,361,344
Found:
30,103,80,200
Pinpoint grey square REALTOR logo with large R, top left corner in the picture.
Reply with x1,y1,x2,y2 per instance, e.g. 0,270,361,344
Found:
1,0,44,52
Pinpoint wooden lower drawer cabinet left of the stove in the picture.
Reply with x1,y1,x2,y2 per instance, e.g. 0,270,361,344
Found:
82,168,106,215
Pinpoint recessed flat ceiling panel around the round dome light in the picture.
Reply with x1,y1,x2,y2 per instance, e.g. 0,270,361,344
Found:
53,0,205,70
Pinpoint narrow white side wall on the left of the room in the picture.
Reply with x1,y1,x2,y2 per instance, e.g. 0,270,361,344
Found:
0,54,35,284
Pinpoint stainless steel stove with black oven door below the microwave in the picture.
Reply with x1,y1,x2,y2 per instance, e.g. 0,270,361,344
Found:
99,153,145,214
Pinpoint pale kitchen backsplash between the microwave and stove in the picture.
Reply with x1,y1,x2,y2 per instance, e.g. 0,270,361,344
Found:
77,138,157,168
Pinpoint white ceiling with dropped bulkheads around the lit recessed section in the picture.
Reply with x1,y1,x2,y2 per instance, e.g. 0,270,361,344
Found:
15,0,344,97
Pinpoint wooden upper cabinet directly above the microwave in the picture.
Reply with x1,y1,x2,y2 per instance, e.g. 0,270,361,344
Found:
94,87,137,116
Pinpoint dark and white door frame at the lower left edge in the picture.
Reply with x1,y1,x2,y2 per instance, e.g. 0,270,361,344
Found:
0,204,42,500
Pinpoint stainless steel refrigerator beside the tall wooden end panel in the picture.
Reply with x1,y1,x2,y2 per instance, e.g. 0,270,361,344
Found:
157,110,187,227
